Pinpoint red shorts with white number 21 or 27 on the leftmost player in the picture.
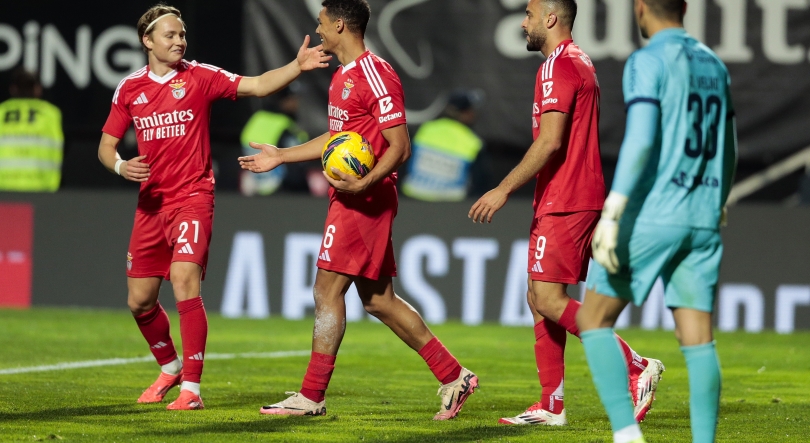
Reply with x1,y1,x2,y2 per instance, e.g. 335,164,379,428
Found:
127,205,214,280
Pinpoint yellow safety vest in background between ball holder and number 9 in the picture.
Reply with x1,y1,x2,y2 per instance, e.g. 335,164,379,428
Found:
402,117,484,201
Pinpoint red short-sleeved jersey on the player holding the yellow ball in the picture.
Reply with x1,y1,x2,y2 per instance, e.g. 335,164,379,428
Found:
329,51,406,187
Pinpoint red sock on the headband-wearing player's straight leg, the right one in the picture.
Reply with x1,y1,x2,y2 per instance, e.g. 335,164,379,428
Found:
177,297,208,383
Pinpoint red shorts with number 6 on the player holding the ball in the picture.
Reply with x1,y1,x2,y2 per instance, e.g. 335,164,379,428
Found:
317,178,398,280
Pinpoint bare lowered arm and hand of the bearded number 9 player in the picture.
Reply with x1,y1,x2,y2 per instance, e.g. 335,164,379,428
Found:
467,111,570,223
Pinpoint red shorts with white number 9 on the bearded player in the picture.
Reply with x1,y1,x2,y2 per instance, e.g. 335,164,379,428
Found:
528,211,599,285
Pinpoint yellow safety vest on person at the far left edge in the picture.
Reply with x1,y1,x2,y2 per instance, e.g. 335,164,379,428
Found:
0,98,65,192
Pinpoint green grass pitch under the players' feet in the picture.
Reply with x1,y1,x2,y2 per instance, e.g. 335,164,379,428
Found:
0,308,810,443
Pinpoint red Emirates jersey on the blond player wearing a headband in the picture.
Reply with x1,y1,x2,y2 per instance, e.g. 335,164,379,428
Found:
102,60,242,212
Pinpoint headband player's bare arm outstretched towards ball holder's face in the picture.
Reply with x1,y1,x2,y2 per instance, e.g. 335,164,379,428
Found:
236,35,332,97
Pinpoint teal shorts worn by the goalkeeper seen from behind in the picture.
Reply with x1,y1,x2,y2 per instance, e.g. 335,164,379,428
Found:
586,222,723,312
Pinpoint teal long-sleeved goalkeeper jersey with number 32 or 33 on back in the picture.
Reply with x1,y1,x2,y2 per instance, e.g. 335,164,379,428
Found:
612,28,736,229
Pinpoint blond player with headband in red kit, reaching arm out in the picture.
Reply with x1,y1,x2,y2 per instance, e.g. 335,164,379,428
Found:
98,4,330,409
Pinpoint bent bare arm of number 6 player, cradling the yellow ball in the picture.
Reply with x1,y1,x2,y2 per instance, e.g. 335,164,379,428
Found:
324,125,411,194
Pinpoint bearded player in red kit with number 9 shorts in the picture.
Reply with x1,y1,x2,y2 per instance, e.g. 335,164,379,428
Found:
468,0,664,426
